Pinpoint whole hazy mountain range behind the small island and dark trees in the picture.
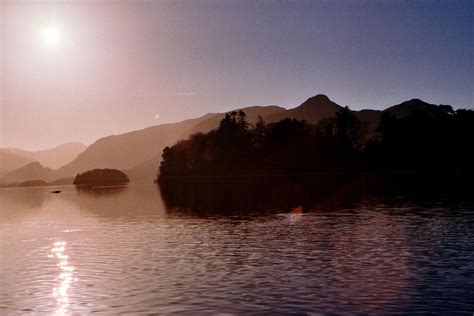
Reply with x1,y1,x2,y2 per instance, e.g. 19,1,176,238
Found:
0,94,460,183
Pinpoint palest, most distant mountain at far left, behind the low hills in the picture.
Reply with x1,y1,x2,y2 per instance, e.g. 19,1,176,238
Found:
6,143,87,169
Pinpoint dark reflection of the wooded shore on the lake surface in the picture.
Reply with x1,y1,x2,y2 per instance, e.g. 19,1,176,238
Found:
159,175,470,215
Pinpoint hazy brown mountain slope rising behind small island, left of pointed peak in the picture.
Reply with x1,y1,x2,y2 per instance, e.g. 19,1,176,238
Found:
57,106,284,181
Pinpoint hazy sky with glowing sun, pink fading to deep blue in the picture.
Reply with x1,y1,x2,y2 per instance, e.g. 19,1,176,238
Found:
0,0,474,149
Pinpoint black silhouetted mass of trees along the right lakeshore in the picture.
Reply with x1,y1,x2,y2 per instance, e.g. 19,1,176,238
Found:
159,106,474,178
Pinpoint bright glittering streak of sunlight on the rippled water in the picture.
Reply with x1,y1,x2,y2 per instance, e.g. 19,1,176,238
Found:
48,241,76,315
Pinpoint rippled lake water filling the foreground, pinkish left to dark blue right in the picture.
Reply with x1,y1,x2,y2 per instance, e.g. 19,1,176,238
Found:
0,178,474,315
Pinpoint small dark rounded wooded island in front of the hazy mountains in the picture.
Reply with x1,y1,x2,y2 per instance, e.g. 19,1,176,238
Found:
73,169,130,186
